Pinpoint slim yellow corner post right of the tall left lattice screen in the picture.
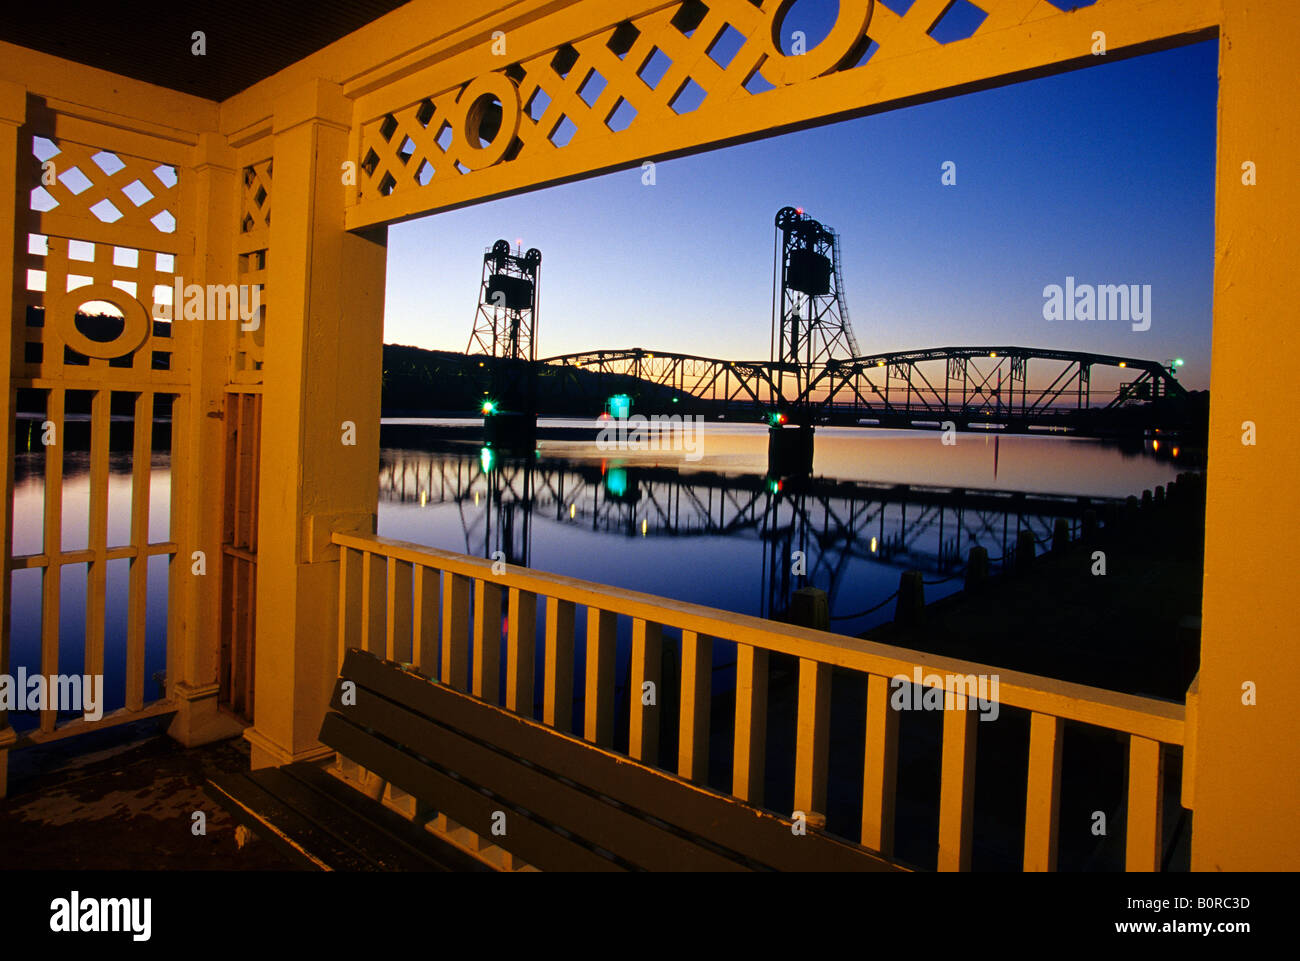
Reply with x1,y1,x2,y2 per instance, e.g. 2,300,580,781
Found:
166,133,243,746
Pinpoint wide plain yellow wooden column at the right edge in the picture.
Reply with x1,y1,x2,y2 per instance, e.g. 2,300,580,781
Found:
1184,0,1300,871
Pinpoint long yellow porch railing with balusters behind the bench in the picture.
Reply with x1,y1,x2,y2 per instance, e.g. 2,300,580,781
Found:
333,533,1184,871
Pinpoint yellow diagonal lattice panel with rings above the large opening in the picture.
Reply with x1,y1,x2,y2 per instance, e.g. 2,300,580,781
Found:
358,0,1061,202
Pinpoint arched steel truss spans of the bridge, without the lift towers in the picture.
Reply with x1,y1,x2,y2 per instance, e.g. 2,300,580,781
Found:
541,346,1187,433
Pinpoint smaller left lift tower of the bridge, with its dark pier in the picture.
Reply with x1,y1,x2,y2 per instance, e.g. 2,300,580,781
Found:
465,241,542,447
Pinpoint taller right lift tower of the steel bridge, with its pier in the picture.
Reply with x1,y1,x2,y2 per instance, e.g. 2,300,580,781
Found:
768,207,861,475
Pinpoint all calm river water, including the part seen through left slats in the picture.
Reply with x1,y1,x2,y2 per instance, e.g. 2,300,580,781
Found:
10,420,1180,727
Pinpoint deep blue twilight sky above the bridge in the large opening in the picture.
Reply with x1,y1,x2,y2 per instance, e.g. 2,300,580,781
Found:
385,27,1218,389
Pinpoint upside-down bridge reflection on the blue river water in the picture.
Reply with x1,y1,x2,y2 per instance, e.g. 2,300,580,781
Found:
380,446,1115,633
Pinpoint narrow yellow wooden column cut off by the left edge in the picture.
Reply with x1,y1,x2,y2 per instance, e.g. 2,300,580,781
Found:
0,82,27,797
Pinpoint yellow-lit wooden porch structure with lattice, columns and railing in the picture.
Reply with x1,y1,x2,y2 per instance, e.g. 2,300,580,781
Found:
0,0,1300,871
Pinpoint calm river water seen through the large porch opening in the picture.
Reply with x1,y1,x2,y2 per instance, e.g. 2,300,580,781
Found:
378,420,1183,633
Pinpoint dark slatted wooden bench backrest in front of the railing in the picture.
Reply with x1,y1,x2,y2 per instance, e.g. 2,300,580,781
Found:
210,649,904,871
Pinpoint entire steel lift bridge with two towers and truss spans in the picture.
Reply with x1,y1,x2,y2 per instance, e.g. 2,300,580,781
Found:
471,207,1187,463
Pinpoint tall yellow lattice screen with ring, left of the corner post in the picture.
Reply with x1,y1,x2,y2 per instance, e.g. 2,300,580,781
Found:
8,129,194,736
